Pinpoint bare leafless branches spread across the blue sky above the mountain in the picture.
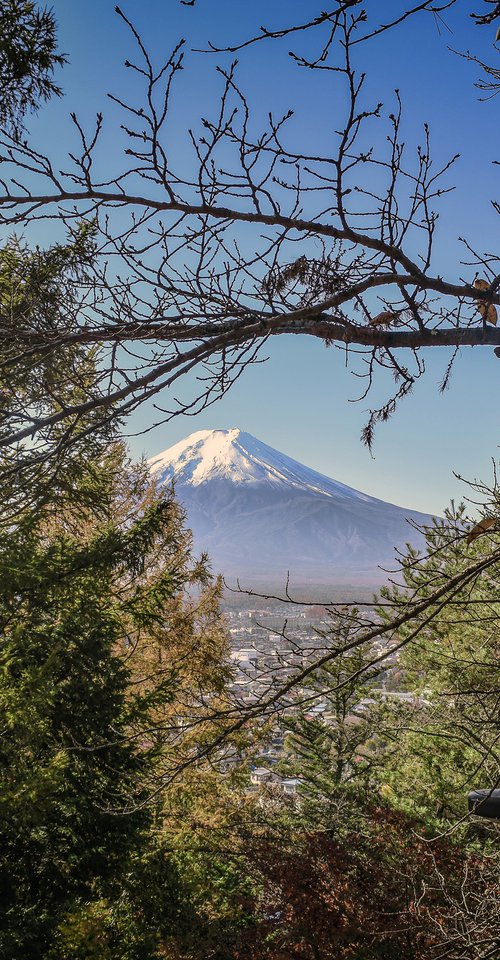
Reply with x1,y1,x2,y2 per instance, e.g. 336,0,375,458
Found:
0,0,500,476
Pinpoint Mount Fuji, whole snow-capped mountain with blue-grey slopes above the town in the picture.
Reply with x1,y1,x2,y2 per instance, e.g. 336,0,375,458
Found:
150,429,432,587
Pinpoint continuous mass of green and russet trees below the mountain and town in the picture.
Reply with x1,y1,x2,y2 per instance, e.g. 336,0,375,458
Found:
0,414,500,960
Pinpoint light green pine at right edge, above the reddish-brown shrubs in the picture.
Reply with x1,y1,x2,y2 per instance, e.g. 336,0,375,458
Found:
378,498,500,832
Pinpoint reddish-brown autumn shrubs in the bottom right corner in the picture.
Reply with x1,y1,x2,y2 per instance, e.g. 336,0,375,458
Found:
231,808,495,960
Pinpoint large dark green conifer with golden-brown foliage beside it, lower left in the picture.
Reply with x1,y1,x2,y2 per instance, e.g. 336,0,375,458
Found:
0,445,230,960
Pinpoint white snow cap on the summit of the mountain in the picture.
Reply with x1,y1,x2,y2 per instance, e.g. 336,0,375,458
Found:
150,428,372,501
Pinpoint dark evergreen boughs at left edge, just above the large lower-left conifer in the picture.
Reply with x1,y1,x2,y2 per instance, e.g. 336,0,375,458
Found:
0,223,116,520
